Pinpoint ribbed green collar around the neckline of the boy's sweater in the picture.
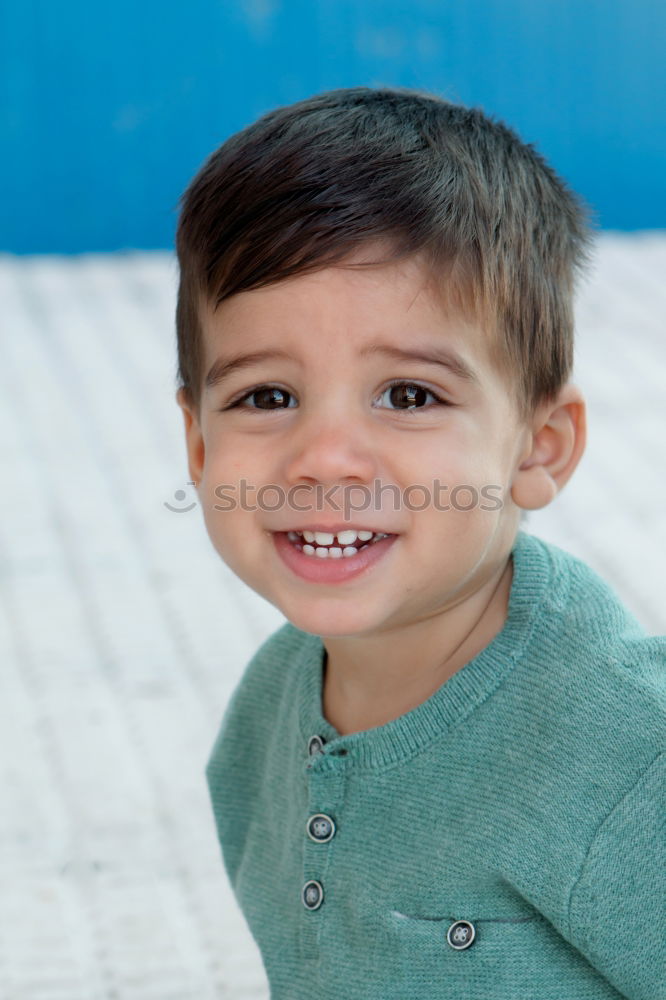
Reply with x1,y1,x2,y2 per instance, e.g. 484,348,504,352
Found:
297,531,555,770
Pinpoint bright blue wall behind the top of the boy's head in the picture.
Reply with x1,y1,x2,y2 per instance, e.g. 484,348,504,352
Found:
0,0,666,253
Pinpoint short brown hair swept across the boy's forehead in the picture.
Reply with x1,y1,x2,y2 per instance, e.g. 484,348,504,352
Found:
176,87,592,417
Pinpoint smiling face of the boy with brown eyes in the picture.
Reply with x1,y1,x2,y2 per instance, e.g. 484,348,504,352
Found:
179,254,529,636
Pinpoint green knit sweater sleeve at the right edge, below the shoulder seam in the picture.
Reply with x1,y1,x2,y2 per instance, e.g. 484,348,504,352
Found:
569,753,666,1000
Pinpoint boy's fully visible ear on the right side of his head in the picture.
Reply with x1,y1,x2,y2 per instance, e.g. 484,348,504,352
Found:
511,382,587,510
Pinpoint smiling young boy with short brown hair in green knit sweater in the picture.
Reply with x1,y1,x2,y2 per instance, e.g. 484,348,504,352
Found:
177,87,666,1000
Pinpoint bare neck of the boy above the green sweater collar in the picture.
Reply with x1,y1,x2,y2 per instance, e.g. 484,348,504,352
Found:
322,555,513,736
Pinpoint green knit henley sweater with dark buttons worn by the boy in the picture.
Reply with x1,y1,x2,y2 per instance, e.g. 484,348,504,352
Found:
206,531,666,1000
